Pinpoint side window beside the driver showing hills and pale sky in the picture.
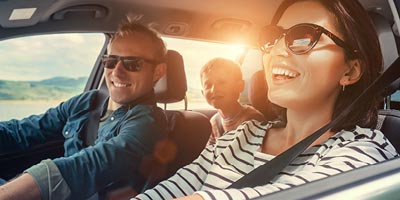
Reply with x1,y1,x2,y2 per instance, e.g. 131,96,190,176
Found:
0,33,106,121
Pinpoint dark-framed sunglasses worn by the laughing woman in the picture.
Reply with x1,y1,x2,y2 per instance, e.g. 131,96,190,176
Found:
259,23,357,57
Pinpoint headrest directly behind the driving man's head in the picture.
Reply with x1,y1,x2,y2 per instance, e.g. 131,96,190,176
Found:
154,50,187,103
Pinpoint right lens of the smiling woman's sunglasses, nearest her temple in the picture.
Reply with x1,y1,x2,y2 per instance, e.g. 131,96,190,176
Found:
285,26,317,54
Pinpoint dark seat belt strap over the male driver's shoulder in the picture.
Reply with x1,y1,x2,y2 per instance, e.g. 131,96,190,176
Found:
83,83,109,147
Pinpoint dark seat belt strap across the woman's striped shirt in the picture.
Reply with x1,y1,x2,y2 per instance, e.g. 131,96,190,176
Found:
228,58,400,189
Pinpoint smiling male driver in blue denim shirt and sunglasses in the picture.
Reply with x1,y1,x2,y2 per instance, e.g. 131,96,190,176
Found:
0,22,166,200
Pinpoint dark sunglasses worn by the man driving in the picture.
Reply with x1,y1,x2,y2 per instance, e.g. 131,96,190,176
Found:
101,55,160,72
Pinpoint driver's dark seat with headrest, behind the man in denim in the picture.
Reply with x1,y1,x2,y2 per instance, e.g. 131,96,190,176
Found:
143,50,211,190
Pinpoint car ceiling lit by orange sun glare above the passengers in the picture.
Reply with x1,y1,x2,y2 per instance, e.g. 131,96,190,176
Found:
0,0,393,46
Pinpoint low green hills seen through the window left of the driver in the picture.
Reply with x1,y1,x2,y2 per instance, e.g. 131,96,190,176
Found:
0,77,87,100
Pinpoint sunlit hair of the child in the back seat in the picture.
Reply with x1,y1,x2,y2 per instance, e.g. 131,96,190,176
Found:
200,57,243,81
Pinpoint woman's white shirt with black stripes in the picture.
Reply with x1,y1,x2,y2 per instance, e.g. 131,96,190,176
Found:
136,120,398,200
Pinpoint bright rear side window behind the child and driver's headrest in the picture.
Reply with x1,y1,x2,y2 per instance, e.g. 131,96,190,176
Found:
163,38,261,109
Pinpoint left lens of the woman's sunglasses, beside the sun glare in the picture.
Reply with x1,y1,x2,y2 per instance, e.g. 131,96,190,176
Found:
259,26,284,53
